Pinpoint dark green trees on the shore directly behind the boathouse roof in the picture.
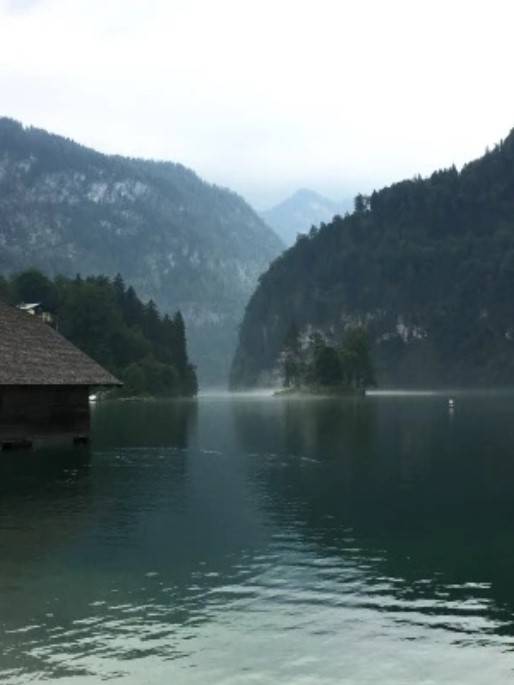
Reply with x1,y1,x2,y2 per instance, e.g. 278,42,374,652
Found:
5,269,198,397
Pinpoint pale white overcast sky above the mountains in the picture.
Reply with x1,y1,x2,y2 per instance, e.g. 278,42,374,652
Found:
0,0,514,209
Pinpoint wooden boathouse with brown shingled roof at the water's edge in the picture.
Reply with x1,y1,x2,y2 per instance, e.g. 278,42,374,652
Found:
0,301,121,449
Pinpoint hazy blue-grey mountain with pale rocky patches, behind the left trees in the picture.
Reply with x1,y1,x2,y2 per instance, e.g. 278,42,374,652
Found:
0,119,282,383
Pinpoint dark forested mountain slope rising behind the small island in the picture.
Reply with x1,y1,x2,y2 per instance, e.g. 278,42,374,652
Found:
231,132,514,387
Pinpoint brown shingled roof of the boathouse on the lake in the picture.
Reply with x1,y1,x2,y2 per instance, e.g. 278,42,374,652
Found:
0,301,121,385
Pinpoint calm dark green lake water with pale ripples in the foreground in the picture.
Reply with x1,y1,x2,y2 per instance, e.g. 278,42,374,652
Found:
0,393,514,685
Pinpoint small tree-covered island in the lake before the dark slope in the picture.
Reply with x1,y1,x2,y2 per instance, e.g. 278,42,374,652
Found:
275,322,376,396
